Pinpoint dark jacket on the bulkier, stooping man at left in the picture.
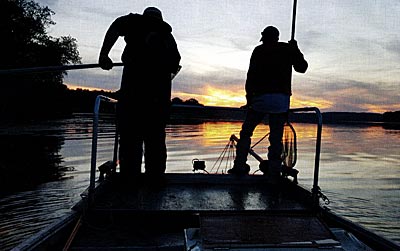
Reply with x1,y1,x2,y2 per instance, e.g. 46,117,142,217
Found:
110,13,181,107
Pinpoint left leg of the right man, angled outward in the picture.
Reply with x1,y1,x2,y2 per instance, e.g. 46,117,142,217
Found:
228,109,265,173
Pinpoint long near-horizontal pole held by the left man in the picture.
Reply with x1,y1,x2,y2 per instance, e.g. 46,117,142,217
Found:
0,63,124,75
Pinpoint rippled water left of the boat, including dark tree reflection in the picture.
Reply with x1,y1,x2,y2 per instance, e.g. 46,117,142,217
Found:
0,114,115,250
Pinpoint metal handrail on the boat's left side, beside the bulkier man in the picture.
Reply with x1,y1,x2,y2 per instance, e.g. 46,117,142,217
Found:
88,95,118,202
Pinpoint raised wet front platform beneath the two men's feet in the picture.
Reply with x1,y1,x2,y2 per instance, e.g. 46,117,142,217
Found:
90,174,309,212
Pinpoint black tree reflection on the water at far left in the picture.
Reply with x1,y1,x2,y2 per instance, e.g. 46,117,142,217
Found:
0,135,66,193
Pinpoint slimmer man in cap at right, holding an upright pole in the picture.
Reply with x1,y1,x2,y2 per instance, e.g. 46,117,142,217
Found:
228,26,308,182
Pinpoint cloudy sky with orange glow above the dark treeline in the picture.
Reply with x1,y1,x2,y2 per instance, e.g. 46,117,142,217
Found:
36,0,400,112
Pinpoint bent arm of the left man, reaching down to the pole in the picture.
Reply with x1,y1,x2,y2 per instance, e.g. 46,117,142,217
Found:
99,19,119,70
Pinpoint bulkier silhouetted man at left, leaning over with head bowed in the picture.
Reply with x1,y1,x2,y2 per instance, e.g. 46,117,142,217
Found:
99,7,181,180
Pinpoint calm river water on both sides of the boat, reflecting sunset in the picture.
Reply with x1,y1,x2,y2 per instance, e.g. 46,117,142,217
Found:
0,115,400,250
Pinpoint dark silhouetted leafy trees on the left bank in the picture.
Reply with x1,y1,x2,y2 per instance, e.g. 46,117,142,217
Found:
0,0,81,119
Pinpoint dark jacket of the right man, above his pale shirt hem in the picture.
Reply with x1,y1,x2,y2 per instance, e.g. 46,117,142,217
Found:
245,42,308,98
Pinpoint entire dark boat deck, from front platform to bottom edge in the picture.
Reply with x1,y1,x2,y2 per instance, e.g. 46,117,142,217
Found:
65,174,342,250
